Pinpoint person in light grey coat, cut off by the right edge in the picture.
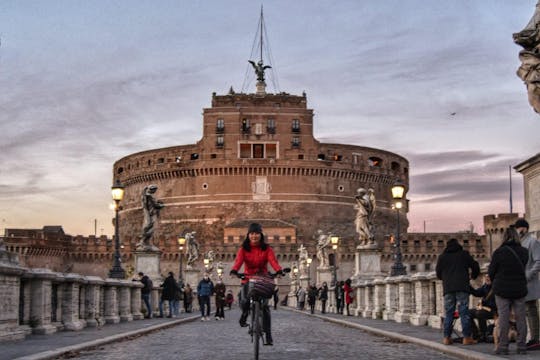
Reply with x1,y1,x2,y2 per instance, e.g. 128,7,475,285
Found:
515,219,540,350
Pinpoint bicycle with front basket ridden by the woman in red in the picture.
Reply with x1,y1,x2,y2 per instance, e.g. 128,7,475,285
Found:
236,268,291,360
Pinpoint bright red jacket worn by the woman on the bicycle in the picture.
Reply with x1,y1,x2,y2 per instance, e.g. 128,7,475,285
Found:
231,245,281,283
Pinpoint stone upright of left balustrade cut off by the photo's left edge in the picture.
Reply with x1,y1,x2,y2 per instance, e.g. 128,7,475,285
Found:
0,249,29,342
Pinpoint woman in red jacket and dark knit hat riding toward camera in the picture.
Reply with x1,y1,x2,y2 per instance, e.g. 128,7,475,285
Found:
230,223,283,345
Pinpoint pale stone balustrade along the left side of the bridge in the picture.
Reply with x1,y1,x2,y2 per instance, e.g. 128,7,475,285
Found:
0,261,173,342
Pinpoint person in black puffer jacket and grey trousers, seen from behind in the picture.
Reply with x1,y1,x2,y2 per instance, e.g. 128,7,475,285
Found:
488,226,529,355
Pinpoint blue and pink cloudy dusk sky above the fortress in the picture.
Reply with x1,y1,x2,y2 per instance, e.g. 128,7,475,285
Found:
0,0,540,235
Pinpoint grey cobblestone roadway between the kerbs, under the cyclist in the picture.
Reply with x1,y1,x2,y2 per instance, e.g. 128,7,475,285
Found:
66,309,455,360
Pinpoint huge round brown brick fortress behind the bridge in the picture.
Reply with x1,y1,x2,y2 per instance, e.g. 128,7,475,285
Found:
113,92,409,261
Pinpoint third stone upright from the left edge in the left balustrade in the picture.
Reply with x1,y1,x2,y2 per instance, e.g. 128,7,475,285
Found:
58,274,83,331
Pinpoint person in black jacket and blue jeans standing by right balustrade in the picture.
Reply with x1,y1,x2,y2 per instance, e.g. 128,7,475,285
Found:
436,238,480,345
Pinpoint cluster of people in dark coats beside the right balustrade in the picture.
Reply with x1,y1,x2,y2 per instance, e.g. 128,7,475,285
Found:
436,219,540,355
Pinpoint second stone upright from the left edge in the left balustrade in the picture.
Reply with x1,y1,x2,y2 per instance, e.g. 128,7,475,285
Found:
30,269,57,335
